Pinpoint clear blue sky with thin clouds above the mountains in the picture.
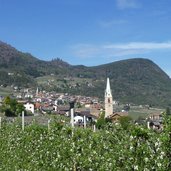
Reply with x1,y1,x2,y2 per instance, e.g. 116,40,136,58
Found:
0,0,171,76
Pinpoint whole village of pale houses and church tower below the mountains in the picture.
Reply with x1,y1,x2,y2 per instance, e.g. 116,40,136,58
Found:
0,78,163,130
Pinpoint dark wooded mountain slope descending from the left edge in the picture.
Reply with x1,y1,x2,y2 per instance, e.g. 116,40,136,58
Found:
0,41,70,86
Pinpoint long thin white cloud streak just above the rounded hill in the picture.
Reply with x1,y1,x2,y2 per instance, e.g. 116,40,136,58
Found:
71,42,171,59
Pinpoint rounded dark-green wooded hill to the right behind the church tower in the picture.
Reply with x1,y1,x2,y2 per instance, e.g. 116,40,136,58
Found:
89,58,171,105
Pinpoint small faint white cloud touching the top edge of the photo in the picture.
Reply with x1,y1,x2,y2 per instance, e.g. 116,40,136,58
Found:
116,0,140,9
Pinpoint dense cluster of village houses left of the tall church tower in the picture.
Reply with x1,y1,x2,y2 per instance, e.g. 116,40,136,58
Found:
13,89,103,125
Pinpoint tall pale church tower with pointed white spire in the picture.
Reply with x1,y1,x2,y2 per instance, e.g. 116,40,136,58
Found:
105,78,113,118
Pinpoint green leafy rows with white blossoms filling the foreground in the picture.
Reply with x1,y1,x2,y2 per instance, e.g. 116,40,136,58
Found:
0,115,171,171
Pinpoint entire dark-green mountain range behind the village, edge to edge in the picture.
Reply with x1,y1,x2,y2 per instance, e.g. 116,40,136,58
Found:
0,42,171,106
